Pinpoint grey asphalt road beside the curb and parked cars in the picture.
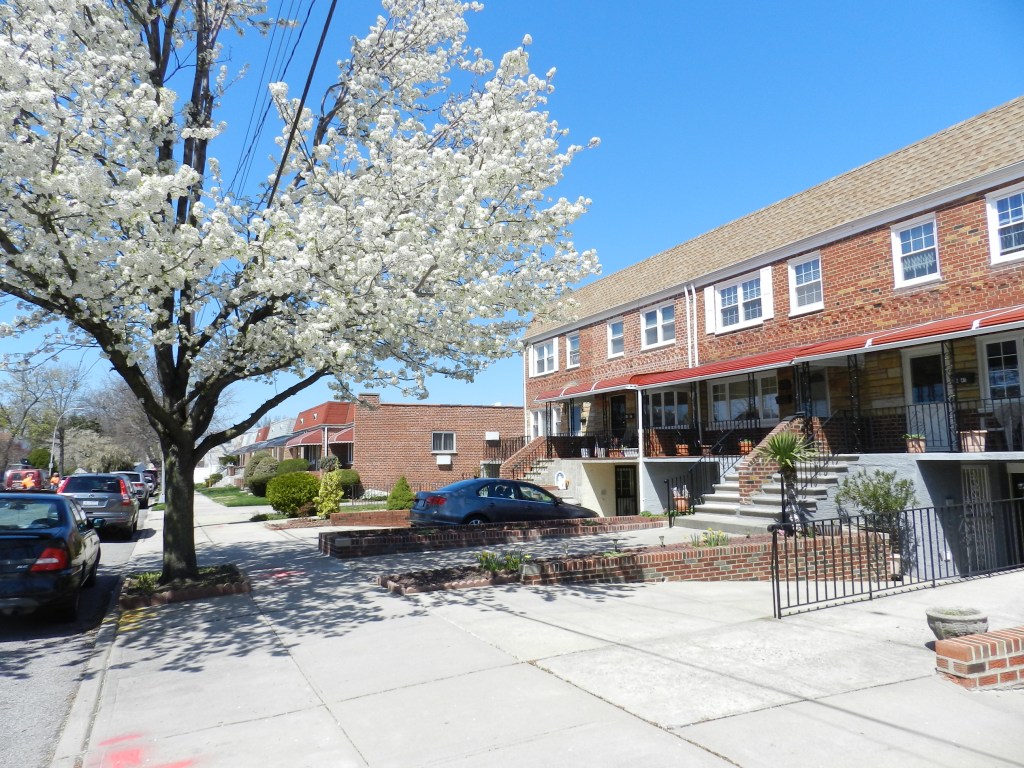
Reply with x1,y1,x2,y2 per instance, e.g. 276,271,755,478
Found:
0,510,154,768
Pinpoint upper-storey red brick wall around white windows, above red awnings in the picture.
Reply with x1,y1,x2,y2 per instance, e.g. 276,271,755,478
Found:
526,185,1024,407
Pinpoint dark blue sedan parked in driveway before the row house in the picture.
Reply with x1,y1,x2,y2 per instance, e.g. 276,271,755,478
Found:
410,477,598,525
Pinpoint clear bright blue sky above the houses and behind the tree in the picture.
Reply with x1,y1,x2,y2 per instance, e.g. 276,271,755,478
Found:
8,0,1024,428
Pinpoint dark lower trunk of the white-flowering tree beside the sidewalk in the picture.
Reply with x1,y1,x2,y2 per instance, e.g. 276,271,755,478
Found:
160,444,199,584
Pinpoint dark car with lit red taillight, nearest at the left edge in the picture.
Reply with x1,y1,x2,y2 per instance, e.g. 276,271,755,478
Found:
0,490,103,622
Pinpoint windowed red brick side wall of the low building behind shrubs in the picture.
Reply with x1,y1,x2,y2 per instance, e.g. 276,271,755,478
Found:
352,395,523,490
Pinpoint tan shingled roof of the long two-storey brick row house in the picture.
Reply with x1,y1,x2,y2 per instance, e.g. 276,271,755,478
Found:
527,96,1024,337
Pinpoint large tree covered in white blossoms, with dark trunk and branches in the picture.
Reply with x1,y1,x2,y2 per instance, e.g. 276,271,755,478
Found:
0,0,597,581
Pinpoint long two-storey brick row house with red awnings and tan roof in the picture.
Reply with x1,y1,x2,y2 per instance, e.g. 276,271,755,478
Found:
523,98,1024,528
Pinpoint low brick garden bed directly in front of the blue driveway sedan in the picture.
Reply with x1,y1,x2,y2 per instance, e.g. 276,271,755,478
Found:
319,515,669,558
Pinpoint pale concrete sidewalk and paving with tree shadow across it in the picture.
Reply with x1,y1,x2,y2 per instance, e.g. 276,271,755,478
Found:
53,497,1024,768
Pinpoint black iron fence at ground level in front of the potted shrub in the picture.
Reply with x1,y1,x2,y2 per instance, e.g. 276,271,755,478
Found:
769,499,1024,618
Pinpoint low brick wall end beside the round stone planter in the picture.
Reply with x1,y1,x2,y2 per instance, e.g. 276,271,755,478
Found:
935,627,1024,690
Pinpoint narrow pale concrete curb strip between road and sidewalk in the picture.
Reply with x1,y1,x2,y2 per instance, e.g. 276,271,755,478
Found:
50,573,125,768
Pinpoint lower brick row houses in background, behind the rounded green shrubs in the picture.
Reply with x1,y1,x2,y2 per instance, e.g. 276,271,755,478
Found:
232,394,522,492
